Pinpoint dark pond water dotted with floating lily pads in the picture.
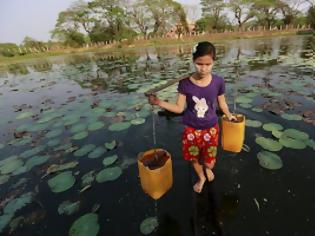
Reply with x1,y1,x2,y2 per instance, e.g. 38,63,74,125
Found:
0,36,315,236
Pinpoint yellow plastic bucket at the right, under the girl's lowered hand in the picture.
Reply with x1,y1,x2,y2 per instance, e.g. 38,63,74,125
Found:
221,114,245,152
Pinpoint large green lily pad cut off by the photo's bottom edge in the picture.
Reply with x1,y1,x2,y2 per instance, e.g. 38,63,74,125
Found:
69,213,100,236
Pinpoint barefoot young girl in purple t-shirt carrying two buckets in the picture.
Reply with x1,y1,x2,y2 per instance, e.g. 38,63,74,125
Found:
148,42,236,193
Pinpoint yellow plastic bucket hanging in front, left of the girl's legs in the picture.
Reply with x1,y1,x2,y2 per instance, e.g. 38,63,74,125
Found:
138,148,173,200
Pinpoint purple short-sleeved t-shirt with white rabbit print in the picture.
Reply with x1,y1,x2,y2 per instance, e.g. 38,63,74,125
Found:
177,74,225,129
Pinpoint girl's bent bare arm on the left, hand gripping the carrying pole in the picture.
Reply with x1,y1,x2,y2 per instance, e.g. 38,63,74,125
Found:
149,93,186,113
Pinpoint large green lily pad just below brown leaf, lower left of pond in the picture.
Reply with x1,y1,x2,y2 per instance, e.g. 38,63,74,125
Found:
48,171,75,193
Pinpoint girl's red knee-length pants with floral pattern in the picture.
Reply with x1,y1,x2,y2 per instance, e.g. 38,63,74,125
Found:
182,124,219,164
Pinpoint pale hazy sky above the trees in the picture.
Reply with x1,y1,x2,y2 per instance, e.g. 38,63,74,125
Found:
0,0,199,44
